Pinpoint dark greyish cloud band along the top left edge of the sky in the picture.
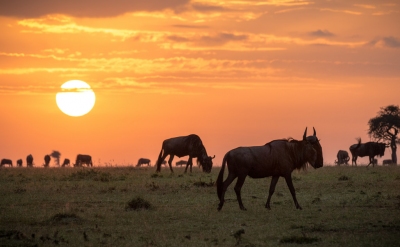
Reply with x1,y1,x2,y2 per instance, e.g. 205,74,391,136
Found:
0,0,190,18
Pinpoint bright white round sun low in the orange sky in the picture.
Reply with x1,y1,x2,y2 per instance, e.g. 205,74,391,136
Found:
56,80,96,117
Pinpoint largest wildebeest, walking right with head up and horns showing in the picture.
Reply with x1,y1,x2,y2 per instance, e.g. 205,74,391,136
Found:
217,128,323,210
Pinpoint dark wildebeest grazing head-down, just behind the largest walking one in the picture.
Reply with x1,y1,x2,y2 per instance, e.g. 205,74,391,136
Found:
156,134,215,173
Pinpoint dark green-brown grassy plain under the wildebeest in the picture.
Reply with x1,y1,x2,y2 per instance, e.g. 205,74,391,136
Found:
0,166,400,246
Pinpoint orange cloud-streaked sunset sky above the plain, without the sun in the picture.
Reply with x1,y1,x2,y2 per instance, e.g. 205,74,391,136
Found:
0,0,400,166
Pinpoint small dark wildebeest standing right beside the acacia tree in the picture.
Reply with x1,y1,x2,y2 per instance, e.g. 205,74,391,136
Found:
349,138,387,166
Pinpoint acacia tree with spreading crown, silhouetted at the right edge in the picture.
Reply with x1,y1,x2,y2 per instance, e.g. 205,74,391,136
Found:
368,105,400,164
